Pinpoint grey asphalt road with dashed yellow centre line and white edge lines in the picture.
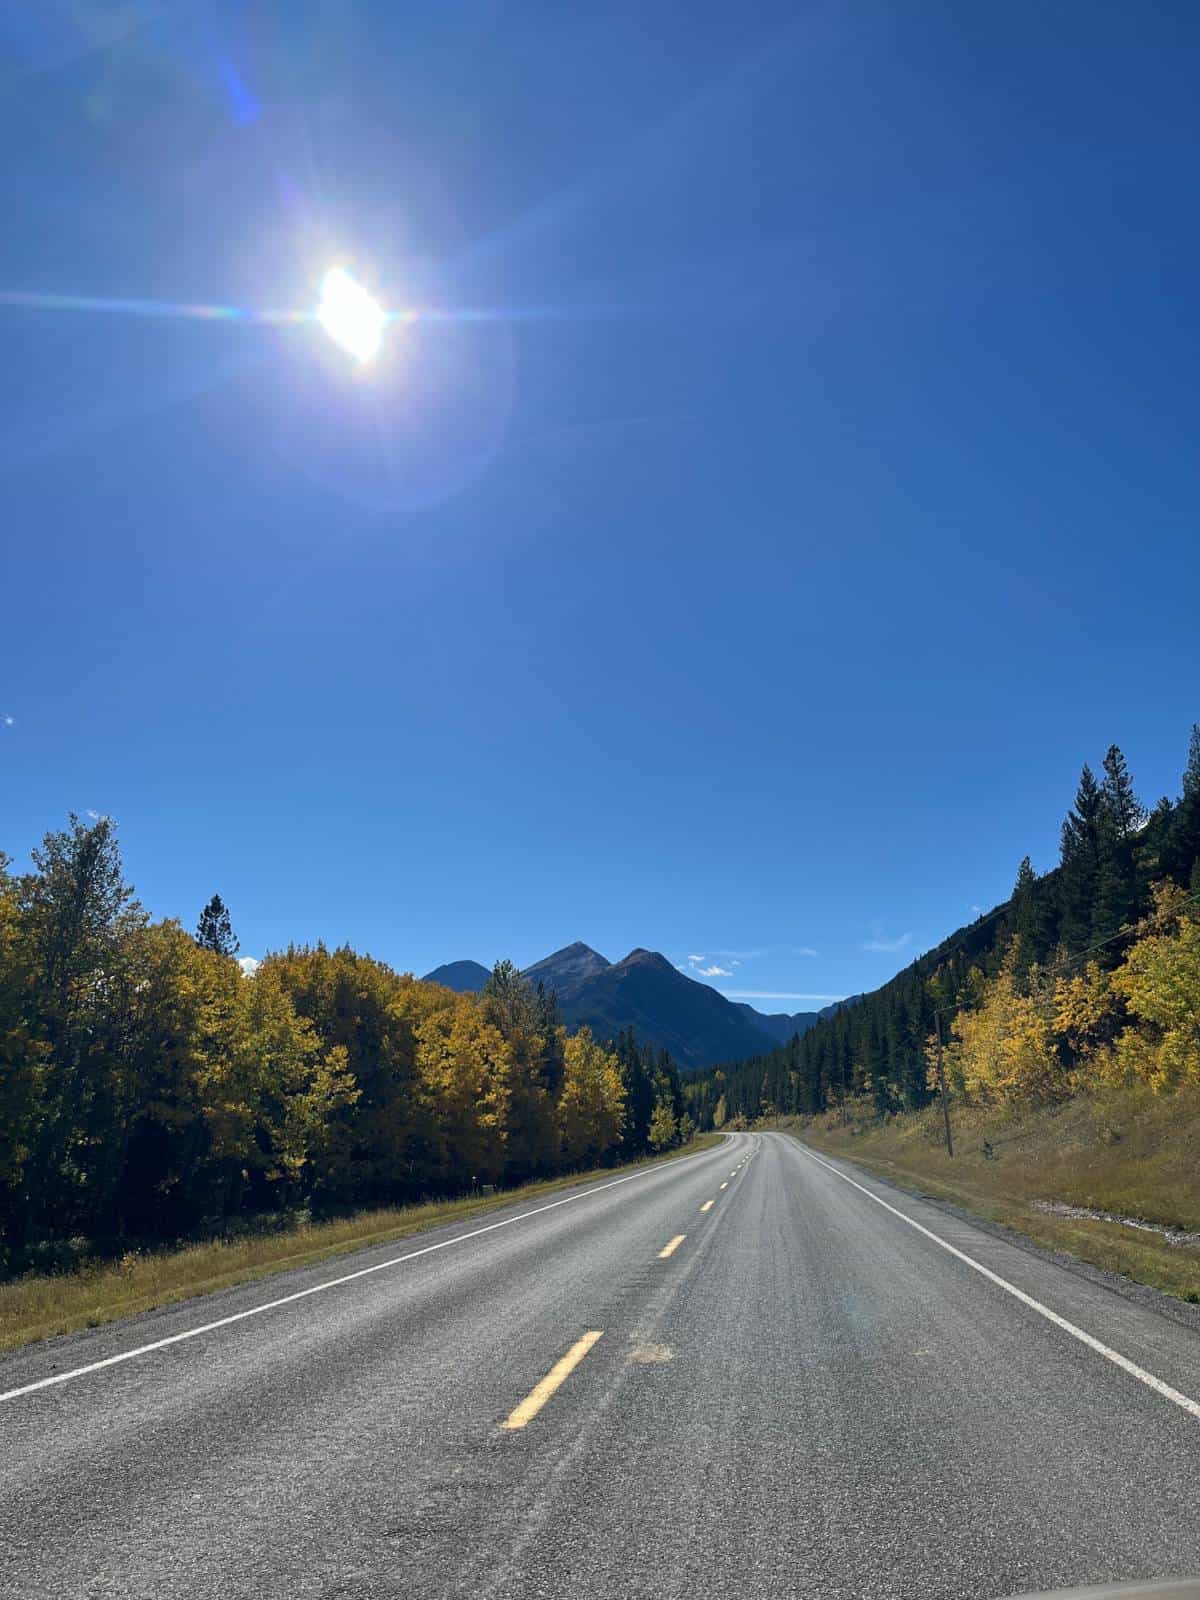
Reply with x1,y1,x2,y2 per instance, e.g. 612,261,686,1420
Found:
0,1134,1200,1600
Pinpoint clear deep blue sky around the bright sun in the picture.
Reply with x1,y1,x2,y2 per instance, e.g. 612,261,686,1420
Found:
0,0,1200,1010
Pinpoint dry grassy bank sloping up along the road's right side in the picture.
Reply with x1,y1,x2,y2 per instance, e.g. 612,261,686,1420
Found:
782,1086,1200,1301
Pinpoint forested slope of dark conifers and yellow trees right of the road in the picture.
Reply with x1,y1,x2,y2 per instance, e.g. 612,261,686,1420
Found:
686,726,1200,1126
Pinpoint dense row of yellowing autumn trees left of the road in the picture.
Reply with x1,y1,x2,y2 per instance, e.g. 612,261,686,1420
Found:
0,816,693,1272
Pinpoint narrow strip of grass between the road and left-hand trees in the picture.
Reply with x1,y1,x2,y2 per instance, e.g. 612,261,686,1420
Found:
0,1133,720,1350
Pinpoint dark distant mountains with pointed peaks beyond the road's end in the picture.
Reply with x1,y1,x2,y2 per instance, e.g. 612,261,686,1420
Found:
426,941,845,1072
